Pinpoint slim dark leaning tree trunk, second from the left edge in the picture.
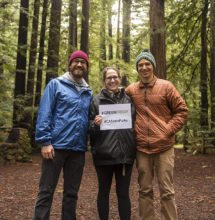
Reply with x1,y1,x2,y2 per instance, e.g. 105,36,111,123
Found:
25,0,40,130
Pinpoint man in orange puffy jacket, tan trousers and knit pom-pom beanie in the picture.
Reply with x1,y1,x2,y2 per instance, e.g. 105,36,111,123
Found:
126,50,188,220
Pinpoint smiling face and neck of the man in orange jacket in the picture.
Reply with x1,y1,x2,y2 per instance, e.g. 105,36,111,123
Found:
137,59,154,83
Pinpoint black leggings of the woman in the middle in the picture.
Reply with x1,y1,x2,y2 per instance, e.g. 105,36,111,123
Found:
95,164,133,220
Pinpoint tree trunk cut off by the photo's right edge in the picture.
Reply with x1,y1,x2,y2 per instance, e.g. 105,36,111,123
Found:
210,0,215,130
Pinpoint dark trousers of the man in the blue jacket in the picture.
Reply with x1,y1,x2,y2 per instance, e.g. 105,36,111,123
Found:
33,149,85,220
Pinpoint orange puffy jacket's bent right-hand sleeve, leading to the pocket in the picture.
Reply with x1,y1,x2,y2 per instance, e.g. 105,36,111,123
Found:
167,83,188,134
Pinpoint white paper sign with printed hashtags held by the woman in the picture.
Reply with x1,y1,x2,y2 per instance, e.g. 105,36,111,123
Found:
99,104,132,130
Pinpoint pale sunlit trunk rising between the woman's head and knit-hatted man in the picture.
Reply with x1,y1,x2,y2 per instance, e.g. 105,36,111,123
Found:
122,0,131,63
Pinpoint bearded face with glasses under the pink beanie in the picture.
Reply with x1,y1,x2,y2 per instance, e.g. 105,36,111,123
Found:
69,58,87,82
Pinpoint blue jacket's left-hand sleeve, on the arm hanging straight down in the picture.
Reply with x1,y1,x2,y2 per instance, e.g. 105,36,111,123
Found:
35,80,56,146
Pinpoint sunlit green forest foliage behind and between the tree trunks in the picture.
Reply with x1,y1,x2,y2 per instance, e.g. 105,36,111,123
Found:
0,0,213,144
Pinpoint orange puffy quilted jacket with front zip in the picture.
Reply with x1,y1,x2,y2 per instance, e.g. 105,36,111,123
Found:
126,76,188,154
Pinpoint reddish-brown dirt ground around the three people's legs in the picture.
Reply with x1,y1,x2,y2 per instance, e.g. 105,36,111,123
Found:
0,149,215,220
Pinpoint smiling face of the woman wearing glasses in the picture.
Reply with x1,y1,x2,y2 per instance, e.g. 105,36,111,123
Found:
104,69,121,92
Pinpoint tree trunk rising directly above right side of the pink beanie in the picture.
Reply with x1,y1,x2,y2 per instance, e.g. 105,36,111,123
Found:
81,0,90,54
